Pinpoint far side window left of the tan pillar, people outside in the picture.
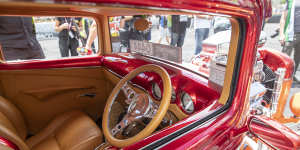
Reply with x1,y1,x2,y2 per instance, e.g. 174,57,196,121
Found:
0,16,98,62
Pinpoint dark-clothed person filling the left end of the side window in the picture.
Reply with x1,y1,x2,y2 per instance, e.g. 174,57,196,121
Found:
0,16,45,60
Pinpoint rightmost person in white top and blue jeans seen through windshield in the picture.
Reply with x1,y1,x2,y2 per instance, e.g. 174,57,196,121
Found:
194,16,211,55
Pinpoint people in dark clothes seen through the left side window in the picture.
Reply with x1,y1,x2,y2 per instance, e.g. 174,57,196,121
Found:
0,16,96,61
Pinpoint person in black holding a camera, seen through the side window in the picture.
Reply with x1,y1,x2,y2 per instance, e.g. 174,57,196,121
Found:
55,17,80,57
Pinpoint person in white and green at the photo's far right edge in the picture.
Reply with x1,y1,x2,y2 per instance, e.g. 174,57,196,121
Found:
279,0,300,83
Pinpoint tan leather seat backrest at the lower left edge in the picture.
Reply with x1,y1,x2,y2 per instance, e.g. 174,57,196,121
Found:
0,96,29,150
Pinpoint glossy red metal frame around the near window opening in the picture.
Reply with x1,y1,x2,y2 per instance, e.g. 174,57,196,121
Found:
97,0,262,149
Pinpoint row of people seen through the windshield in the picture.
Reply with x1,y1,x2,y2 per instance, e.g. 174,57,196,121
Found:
114,15,214,55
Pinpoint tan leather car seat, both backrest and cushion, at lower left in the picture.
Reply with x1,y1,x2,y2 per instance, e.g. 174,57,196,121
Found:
0,96,103,150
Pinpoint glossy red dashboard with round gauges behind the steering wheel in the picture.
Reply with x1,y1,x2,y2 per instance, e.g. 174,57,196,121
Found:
102,53,220,115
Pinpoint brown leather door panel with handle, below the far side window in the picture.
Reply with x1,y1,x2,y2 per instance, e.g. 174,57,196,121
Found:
0,67,110,134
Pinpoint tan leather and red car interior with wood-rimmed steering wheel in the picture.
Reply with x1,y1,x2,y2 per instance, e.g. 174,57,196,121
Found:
0,2,239,150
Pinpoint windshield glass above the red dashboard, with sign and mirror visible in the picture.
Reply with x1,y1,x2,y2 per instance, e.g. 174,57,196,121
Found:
109,15,231,90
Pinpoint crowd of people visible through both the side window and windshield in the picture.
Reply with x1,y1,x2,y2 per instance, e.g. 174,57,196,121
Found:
0,15,220,60
